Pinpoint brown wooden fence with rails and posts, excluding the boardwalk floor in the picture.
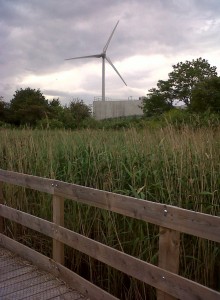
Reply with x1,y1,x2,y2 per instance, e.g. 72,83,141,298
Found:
0,170,220,300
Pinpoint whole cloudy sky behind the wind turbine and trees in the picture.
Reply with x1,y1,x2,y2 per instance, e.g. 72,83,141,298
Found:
0,0,220,105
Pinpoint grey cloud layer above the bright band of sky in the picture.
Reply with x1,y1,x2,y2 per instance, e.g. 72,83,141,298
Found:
0,0,220,102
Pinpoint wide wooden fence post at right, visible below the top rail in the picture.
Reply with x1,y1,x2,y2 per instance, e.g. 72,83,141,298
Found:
157,227,180,300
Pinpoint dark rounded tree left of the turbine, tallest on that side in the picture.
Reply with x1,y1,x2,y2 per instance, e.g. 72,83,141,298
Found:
10,88,49,126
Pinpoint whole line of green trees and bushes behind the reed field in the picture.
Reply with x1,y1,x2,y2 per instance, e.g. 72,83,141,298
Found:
0,58,220,129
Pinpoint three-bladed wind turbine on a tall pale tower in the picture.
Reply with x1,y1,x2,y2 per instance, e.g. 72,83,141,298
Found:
65,21,127,101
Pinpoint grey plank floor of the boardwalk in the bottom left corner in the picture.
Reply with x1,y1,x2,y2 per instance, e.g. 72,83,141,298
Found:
0,247,88,300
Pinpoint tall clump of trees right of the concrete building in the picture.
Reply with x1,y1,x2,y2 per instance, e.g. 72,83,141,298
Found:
143,57,220,117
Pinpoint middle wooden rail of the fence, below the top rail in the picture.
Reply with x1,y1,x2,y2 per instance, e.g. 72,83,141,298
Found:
0,206,220,300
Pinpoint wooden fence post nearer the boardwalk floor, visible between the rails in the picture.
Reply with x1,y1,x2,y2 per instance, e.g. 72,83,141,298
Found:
53,195,64,265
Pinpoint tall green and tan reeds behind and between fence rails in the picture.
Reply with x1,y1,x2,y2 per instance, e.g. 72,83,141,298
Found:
0,125,220,299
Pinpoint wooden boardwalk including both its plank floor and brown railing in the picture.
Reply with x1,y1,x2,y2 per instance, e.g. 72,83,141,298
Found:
0,169,220,300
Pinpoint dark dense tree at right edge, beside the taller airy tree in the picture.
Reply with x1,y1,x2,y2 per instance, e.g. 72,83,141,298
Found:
190,77,220,112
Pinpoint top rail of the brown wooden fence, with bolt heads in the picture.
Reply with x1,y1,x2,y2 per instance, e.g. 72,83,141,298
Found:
0,170,220,243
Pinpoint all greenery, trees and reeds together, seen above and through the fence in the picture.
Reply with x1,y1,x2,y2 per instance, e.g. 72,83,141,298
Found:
0,58,220,300
